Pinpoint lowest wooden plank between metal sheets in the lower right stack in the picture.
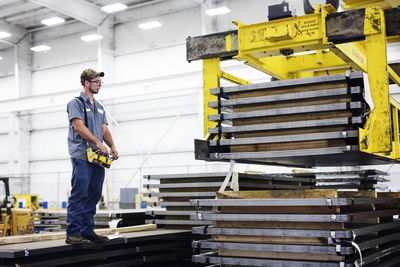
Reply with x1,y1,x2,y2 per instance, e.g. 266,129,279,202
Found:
218,249,345,262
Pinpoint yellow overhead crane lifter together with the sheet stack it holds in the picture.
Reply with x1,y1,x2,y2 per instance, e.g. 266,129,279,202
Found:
186,0,400,167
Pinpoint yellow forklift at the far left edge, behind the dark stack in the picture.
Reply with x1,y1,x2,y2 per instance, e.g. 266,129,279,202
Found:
0,177,33,237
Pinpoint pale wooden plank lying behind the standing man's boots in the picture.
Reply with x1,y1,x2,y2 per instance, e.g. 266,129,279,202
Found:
0,224,157,245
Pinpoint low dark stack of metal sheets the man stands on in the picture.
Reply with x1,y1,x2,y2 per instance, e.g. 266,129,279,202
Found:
0,230,195,267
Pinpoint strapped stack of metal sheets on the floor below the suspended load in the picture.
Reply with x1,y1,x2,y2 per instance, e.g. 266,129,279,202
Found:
191,190,400,267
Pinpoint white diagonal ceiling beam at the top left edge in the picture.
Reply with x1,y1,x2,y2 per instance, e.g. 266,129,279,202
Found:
28,0,107,27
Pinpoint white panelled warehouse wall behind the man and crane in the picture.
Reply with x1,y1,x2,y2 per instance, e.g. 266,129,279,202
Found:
0,0,400,205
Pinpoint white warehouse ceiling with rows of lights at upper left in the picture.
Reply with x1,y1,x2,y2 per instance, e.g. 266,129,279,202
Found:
0,0,200,50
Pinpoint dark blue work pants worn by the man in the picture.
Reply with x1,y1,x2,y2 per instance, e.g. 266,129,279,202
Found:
67,159,104,237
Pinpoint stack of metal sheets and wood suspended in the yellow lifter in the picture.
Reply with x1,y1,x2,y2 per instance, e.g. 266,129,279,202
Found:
195,72,398,167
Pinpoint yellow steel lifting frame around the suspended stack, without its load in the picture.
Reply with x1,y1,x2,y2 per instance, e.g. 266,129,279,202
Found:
203,5,400,159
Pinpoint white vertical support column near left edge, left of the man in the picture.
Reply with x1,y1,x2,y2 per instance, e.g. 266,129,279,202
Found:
8,34,32,194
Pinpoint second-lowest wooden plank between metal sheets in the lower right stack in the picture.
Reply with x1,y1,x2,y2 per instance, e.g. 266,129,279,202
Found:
212,235,328,246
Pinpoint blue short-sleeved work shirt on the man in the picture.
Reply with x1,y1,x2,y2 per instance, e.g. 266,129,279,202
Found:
67,93,108,160
